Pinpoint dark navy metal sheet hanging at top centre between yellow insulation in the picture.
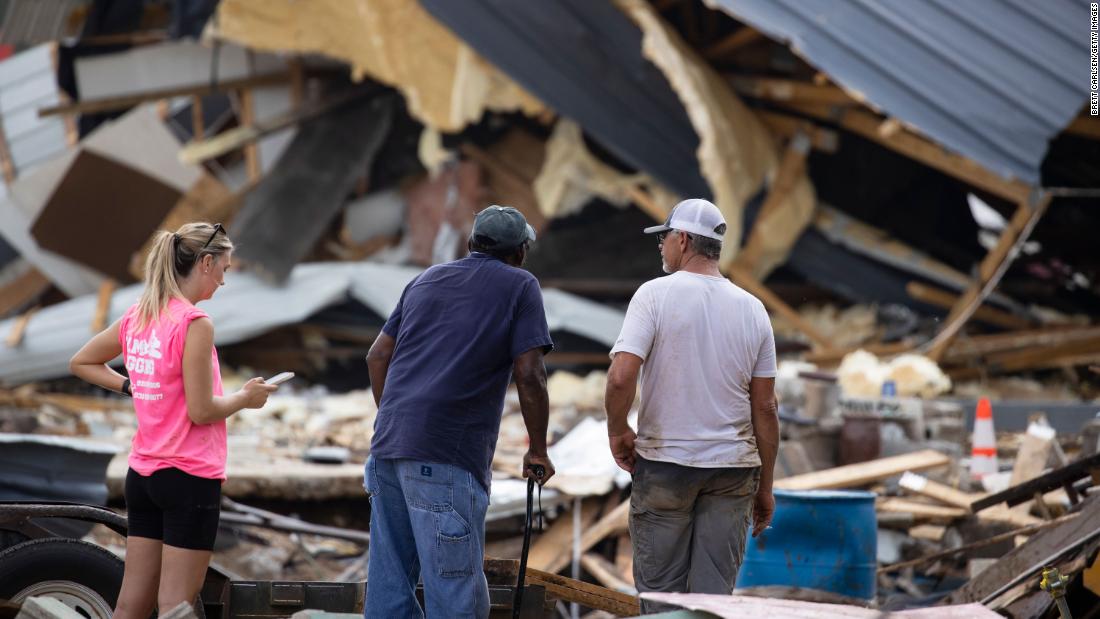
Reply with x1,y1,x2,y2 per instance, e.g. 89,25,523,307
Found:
420,0,711,197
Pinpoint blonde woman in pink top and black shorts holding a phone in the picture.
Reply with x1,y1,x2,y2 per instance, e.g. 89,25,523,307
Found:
69,223,276,619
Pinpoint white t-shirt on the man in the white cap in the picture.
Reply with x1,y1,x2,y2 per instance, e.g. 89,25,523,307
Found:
611,270,776,468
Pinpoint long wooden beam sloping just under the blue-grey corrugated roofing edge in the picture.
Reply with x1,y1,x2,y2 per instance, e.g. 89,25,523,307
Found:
782,101,1032,202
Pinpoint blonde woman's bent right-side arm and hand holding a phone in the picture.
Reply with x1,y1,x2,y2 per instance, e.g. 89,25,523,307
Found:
184,318,278,423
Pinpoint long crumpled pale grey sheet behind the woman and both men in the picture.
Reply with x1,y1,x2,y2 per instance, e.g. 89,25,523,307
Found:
0,263,623,385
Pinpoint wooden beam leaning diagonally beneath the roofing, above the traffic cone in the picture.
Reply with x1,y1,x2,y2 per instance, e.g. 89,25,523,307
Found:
928,195,1051,363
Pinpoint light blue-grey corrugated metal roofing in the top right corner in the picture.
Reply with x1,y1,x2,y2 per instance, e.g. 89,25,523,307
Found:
706,0,1089,185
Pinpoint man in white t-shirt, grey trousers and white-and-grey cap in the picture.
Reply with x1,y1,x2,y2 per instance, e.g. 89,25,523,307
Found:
605,199,779,612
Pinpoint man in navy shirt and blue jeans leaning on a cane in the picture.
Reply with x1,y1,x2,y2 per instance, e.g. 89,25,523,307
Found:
364,206,554,618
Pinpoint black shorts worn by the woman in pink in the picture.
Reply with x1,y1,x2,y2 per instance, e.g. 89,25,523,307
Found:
125,468,221,550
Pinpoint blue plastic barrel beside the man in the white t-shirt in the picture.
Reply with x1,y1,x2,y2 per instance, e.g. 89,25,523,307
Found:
737,489,878,599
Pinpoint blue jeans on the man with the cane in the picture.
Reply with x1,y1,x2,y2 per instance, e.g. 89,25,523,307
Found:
363,456,490,619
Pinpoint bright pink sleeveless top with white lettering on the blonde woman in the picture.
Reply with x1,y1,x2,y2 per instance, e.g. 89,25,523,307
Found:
119,298,226,479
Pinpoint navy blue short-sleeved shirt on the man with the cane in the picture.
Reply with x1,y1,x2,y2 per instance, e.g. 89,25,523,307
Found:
371,253,553,490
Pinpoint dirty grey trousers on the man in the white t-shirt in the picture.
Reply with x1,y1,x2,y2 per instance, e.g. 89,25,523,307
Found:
630,457,760,615
